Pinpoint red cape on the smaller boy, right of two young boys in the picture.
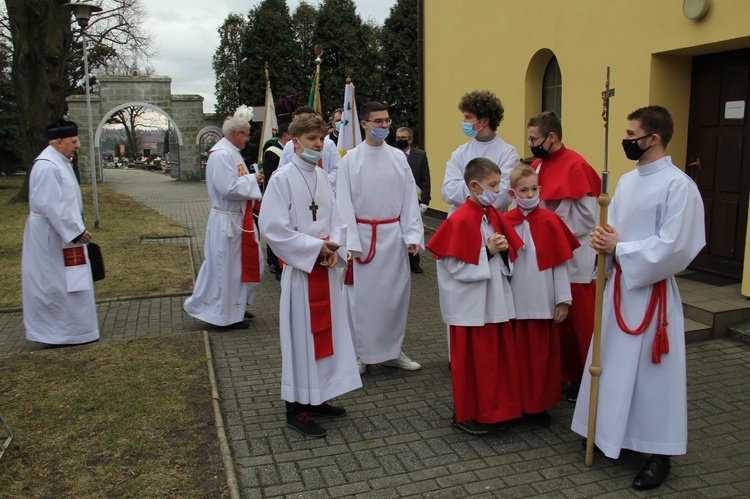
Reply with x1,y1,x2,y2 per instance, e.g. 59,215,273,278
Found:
502,207,581,271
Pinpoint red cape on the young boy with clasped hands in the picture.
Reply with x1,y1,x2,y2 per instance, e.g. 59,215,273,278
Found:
427,199,523,265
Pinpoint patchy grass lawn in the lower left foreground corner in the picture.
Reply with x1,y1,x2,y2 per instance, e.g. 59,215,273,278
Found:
0,333,228,498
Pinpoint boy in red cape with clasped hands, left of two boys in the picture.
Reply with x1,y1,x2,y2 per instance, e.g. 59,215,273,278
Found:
427,158,523,436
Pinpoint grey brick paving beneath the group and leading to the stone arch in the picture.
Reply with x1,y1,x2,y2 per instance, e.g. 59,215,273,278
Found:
0,170,750,498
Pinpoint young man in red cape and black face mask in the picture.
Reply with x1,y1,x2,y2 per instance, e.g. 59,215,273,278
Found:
527,111,602,402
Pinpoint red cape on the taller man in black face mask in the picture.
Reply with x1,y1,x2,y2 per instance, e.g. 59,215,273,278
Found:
531,145,602,201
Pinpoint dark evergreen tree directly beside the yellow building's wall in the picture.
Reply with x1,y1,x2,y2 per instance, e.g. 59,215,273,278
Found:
380,0,420,144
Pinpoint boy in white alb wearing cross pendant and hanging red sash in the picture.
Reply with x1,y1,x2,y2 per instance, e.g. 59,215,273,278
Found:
260,114,362,437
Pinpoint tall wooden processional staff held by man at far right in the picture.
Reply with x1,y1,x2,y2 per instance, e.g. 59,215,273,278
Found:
586,66,615,466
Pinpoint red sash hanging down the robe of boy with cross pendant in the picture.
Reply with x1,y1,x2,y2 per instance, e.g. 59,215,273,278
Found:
307,263,333,360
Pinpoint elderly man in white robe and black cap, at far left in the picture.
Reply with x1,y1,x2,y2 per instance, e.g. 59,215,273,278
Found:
21,120,99,345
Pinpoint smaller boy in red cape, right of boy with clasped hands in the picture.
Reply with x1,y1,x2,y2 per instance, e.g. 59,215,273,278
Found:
503,165,580,427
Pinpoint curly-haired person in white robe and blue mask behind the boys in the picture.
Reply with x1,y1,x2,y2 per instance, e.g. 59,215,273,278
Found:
441,90,520,216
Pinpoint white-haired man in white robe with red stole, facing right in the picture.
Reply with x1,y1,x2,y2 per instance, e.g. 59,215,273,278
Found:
183,106,263,329
